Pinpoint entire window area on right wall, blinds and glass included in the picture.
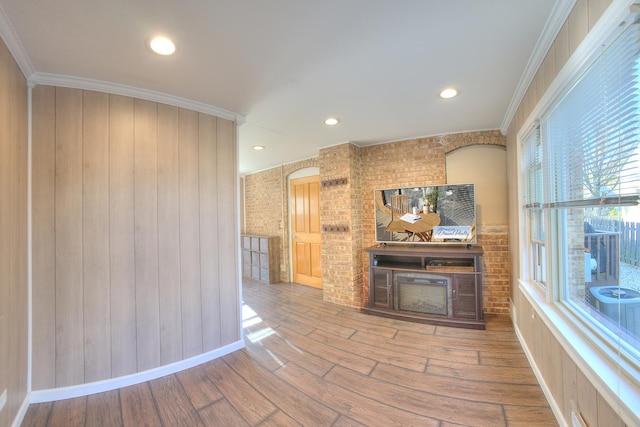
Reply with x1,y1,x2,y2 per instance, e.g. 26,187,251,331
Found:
521,16,640,365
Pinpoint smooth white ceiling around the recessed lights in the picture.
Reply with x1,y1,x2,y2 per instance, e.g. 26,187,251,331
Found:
0,0,571,175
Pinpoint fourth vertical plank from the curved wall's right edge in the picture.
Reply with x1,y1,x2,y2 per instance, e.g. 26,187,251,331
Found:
158,104,182,364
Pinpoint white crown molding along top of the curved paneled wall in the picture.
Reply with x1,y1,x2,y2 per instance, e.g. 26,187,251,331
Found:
28,73,245,125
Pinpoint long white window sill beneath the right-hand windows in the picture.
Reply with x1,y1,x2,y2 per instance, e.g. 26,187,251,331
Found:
519,281,640,425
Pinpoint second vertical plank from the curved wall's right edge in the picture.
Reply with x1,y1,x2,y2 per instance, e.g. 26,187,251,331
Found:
198,114,220,351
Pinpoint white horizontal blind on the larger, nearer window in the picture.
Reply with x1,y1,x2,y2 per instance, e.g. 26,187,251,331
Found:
541,23,640,208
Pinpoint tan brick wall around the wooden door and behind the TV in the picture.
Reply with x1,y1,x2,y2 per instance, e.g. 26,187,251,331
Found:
244,131,510,314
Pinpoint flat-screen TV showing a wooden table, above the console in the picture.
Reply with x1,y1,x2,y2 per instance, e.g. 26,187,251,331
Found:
374,184,476,244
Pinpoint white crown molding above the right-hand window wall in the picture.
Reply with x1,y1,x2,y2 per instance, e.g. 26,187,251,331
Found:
500,0,576,135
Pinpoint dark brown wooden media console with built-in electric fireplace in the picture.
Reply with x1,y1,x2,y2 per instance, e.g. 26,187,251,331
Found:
362,245,485,329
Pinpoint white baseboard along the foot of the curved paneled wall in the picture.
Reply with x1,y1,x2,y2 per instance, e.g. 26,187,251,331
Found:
27,340,245,404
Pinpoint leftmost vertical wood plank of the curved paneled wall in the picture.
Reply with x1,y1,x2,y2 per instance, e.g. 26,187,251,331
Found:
31,86,56,390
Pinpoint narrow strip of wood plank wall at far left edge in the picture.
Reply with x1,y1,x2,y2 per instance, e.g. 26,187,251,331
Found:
0,31,28,426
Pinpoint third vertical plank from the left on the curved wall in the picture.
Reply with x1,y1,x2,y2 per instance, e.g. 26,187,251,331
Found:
82,91,111,382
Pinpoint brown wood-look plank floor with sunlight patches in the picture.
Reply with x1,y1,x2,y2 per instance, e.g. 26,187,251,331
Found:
22,279,558,427
